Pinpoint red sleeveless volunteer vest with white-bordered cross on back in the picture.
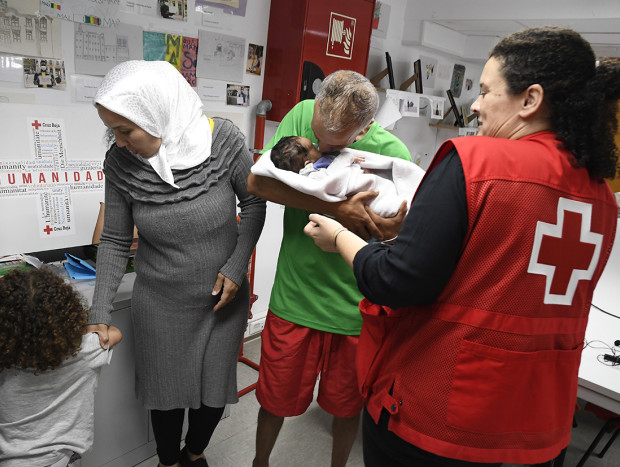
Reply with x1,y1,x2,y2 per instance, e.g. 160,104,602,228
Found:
357,132,617,464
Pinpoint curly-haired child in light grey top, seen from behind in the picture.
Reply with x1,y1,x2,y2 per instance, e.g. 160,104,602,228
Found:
0,269,122,467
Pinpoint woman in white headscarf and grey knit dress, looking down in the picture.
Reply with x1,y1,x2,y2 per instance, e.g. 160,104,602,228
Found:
89,61,265,466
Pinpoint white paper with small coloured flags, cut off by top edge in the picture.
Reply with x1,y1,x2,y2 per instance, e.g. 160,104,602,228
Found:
40,0,121,28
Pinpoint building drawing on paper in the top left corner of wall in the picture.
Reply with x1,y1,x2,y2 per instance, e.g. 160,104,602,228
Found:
0,0,62,58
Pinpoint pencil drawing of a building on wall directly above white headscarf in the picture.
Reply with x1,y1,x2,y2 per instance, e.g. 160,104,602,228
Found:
73,23,142,76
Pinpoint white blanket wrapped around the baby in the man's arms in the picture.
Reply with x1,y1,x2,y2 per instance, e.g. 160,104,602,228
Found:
252,148,424,217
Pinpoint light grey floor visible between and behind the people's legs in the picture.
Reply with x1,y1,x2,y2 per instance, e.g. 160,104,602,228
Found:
137,339,620,467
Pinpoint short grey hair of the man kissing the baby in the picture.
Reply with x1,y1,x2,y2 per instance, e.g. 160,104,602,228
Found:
316,70,379,132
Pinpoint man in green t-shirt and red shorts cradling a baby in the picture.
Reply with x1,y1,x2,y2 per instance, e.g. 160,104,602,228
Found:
248,71,411,467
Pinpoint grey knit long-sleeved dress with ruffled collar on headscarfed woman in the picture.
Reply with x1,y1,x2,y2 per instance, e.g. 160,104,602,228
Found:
89,119,265,410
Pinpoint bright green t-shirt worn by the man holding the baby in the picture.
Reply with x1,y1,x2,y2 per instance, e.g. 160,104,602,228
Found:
265,100,411,335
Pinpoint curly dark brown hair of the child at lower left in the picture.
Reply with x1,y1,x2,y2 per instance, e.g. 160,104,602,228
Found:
0,268,88,374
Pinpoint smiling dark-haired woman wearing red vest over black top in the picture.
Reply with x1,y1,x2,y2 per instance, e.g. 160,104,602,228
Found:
305,28,620,467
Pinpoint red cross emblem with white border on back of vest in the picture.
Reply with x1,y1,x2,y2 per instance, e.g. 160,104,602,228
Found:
527,198,603,305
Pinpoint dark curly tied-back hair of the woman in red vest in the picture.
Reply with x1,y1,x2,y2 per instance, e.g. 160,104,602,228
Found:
490,27,620,181
